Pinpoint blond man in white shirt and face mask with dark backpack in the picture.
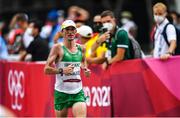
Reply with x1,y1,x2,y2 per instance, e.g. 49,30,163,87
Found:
153,2,177,60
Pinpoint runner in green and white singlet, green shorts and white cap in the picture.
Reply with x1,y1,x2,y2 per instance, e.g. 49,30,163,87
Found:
44,20,90,117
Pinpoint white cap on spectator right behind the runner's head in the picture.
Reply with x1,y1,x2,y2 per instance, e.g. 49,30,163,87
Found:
77,25,93,38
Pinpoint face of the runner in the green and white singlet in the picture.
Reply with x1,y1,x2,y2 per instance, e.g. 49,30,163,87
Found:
63,26,77,41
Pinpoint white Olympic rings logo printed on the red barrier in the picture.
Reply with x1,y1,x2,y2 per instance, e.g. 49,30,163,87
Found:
8,70,25,111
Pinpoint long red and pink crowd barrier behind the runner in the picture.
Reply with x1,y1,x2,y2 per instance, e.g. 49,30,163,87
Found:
0,57,180,117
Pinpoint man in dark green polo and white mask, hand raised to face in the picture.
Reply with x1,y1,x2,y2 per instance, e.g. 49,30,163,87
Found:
92,10,132,68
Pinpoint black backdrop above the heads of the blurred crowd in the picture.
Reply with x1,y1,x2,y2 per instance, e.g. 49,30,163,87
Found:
0,0,180,53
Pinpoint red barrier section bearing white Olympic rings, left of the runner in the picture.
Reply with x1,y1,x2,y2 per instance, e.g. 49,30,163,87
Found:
1,62,54,116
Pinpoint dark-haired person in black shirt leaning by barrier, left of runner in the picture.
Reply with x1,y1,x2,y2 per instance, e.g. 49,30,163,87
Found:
21,21,49,61
